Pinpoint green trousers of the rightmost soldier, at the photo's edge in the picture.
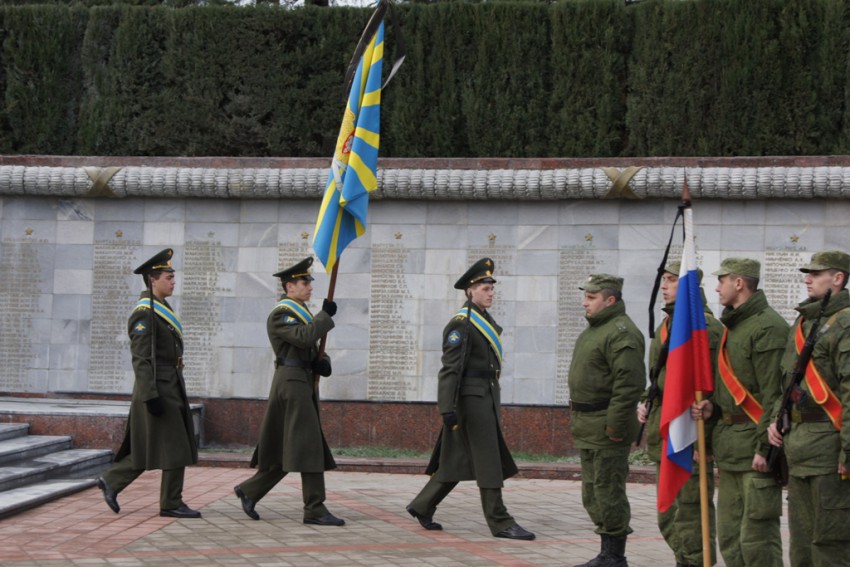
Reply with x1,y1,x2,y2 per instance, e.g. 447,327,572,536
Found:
788,474,850,567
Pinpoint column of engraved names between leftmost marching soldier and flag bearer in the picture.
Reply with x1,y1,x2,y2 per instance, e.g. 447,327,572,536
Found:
178,240,229,394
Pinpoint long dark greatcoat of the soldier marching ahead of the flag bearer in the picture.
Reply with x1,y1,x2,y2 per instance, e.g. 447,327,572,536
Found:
426,304,517,488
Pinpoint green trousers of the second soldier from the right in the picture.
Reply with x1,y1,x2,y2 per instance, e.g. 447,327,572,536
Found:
717,469,782,567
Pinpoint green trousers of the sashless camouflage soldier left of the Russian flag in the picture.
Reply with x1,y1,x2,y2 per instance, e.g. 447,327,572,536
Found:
581,447,632,538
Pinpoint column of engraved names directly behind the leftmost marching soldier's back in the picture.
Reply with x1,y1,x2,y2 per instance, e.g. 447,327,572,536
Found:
88,239,141,392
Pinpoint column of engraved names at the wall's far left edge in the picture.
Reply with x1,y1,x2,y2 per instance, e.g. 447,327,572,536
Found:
0,238,47,391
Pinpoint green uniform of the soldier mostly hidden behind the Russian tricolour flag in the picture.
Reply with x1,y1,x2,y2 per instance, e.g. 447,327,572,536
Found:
644,296,723,565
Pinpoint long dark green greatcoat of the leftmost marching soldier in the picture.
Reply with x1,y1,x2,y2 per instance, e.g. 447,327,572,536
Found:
115,291,198,470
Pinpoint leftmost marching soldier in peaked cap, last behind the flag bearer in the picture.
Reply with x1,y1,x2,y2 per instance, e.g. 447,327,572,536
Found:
97,248,201,518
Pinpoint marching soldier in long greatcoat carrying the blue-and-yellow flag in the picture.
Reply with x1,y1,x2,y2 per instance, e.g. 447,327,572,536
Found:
234,257,345,526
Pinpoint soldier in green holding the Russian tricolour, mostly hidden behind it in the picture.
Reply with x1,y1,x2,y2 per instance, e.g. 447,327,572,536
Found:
638,260,723,567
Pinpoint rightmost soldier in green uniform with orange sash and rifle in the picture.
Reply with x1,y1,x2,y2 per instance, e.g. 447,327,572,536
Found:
768,250,850,567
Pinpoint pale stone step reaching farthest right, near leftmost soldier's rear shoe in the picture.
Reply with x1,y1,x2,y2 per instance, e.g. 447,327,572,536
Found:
0,449,112,492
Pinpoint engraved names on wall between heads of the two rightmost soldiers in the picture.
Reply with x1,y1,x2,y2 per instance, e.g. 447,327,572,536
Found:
760,248,809,323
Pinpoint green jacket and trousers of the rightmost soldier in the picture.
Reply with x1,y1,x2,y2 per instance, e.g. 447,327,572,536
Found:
774,290,850,567
